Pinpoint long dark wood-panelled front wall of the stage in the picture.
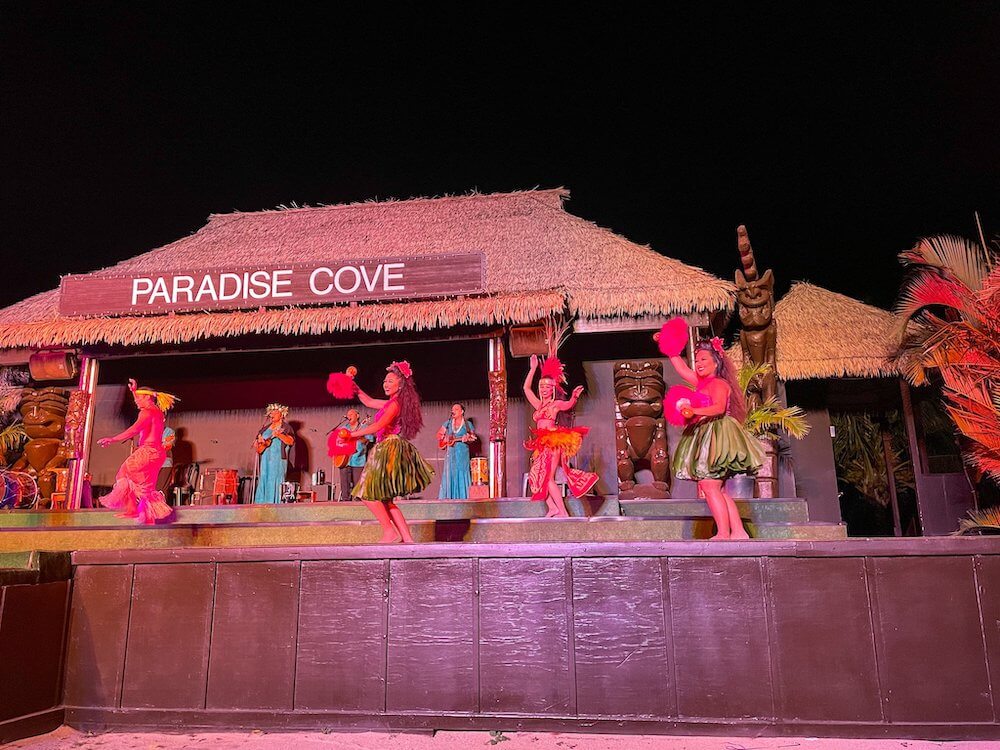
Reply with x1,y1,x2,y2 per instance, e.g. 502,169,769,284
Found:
64,538,1000,739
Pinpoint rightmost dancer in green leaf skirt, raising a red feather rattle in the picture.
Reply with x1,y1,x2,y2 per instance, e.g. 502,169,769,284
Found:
654,318,764,539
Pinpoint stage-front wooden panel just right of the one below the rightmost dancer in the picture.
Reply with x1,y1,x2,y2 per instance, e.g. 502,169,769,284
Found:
765,557,882,721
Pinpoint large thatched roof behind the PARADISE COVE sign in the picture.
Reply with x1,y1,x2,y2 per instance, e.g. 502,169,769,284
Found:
0,189,733,348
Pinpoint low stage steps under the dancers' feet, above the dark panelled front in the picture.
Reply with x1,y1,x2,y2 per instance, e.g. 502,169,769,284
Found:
0,496,846,551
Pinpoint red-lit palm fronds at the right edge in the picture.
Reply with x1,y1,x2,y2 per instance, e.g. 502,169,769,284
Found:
896,235,1000,480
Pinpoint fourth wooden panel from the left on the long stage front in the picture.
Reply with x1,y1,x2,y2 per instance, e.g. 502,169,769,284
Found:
295,560,388,713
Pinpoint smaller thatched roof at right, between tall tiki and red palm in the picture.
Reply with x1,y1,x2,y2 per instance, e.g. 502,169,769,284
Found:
730,281,899,380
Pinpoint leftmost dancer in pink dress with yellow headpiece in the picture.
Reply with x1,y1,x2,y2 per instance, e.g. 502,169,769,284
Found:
97,379,177,523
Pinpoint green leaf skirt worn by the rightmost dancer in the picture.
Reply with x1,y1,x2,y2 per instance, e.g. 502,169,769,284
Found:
673,415,764,479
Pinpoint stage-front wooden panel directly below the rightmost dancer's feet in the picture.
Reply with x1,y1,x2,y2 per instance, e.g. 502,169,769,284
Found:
669,557,774,718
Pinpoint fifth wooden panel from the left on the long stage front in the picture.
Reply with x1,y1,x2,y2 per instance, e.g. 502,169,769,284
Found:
386,560,478,712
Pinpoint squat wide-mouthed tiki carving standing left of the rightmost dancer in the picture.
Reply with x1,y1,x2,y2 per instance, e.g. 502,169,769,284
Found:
614,359,670,499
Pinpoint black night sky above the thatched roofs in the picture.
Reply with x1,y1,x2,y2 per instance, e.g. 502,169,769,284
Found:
0,5,1000,306
